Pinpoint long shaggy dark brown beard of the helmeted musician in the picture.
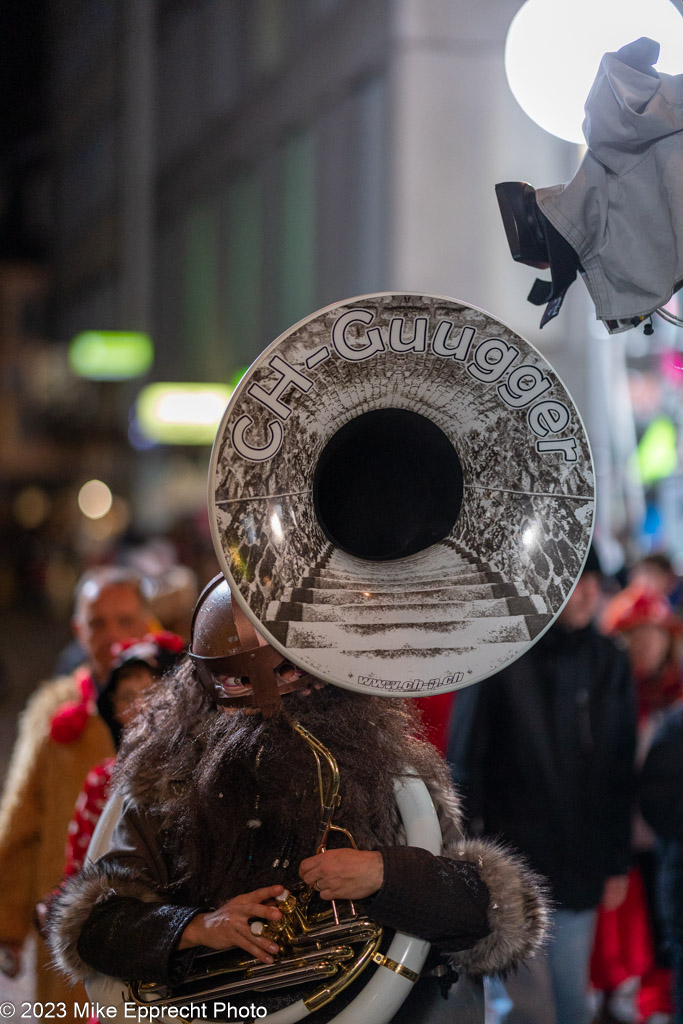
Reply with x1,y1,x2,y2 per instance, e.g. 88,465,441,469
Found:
117,660,450,903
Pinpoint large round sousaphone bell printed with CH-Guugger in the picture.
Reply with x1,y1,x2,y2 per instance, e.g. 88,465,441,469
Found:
209,293,594,696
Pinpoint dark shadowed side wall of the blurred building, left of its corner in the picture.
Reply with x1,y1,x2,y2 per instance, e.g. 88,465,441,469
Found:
53,0,393,380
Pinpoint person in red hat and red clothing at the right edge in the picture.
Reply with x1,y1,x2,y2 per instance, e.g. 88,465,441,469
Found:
592,585,683,1021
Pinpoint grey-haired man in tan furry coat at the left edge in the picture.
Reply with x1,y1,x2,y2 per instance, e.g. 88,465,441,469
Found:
0,568,156,1005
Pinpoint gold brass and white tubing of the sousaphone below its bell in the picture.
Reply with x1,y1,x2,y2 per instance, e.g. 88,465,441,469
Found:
87,722,441,1024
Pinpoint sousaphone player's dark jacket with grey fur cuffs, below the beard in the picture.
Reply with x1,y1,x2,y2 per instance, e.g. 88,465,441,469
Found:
51,770,546,1024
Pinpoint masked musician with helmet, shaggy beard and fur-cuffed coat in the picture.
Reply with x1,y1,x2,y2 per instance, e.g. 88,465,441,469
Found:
51,577,546,1024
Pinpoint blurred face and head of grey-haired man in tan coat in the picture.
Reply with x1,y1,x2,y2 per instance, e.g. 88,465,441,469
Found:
74,584,152,679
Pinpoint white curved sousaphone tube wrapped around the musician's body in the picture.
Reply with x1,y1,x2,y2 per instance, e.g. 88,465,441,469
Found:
86,776,442,1024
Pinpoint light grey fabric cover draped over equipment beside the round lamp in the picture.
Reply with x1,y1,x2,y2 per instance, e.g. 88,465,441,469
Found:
536,39,683,333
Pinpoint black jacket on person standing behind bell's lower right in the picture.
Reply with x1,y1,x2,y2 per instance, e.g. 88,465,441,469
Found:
447,626,636,910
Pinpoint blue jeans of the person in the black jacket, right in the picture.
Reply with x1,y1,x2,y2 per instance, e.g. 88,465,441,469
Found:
500,910,597,1024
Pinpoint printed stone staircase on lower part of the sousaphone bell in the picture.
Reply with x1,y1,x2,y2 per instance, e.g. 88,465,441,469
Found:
263,540,552,690
